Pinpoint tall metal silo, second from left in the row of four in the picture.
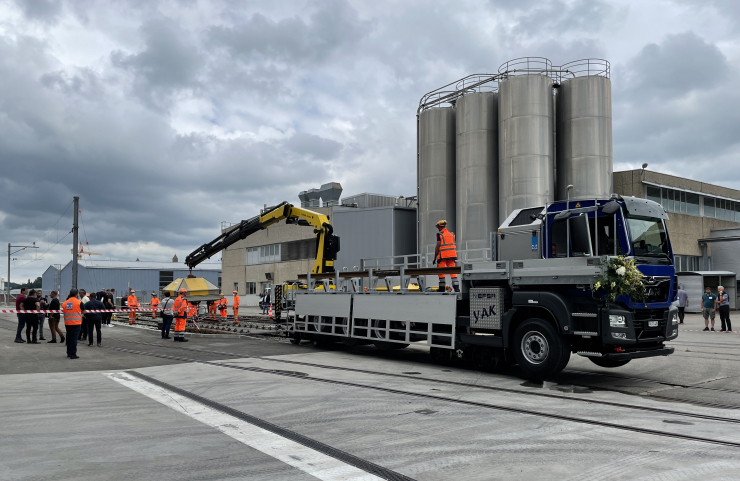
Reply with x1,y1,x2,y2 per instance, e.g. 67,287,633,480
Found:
455,92,499,250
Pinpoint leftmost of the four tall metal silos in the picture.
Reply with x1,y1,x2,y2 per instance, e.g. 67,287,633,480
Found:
418,107,455,254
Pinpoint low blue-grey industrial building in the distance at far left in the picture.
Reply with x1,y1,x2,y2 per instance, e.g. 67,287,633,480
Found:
41,259,221,302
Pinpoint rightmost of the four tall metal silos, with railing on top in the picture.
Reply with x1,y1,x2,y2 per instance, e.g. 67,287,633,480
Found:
557,60,613,199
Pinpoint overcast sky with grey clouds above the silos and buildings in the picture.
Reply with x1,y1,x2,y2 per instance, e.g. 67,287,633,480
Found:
0,0,740,282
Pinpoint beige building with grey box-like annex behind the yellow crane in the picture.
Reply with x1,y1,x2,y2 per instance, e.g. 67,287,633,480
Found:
222,182,416,305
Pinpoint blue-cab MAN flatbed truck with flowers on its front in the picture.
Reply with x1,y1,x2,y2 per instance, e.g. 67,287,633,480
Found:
286,195,678,378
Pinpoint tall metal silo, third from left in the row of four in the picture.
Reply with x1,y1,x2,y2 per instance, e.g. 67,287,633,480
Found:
498,72,555,222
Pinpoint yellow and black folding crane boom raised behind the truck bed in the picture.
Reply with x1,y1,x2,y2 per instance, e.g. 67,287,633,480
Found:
185,202,339,274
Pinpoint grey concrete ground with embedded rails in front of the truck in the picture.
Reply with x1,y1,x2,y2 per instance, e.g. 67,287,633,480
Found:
0,313,740,481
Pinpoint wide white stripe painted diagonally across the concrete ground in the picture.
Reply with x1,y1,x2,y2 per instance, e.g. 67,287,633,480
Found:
105,372,382,481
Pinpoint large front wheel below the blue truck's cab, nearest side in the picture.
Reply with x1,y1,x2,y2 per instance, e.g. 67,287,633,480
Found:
512,318,570,379
